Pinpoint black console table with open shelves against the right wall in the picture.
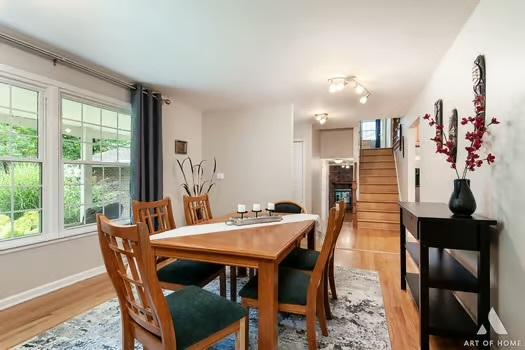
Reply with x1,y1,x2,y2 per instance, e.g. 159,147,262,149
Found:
399,202,497,350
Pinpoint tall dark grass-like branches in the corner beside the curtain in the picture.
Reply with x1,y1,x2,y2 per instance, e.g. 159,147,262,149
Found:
177,157,217,197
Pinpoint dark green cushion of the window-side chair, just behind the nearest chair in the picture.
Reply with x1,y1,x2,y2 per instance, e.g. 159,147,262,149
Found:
157,260,224,286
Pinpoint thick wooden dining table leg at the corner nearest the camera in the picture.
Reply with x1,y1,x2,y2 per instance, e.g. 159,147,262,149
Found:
258,261,279,350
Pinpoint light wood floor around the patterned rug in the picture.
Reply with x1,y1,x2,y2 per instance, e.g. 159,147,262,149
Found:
0,222,464,350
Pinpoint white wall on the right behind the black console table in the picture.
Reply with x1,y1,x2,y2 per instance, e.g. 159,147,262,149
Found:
403,0,525,343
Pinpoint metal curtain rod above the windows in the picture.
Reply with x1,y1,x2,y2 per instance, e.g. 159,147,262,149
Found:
0,32,171,104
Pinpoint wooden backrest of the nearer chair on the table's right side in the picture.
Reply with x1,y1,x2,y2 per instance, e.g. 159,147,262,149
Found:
307,206,344,304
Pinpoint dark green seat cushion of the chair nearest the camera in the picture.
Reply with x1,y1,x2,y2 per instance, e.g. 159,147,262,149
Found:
166,286,247,349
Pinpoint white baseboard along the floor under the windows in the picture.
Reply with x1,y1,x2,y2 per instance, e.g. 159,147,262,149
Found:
0,265,106,310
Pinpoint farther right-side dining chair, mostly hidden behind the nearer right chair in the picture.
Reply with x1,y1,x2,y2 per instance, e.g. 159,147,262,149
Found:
280,201,346,320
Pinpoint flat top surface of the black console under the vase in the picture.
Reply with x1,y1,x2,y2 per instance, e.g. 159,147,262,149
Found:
399,202,498,225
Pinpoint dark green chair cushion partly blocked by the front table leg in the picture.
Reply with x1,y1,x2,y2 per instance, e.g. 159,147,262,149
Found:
239,267,310,305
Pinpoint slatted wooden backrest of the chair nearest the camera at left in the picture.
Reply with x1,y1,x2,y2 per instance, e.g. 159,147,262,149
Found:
97,214,176,349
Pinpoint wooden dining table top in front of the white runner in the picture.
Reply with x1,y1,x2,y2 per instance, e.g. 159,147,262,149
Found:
151,218,315,260
